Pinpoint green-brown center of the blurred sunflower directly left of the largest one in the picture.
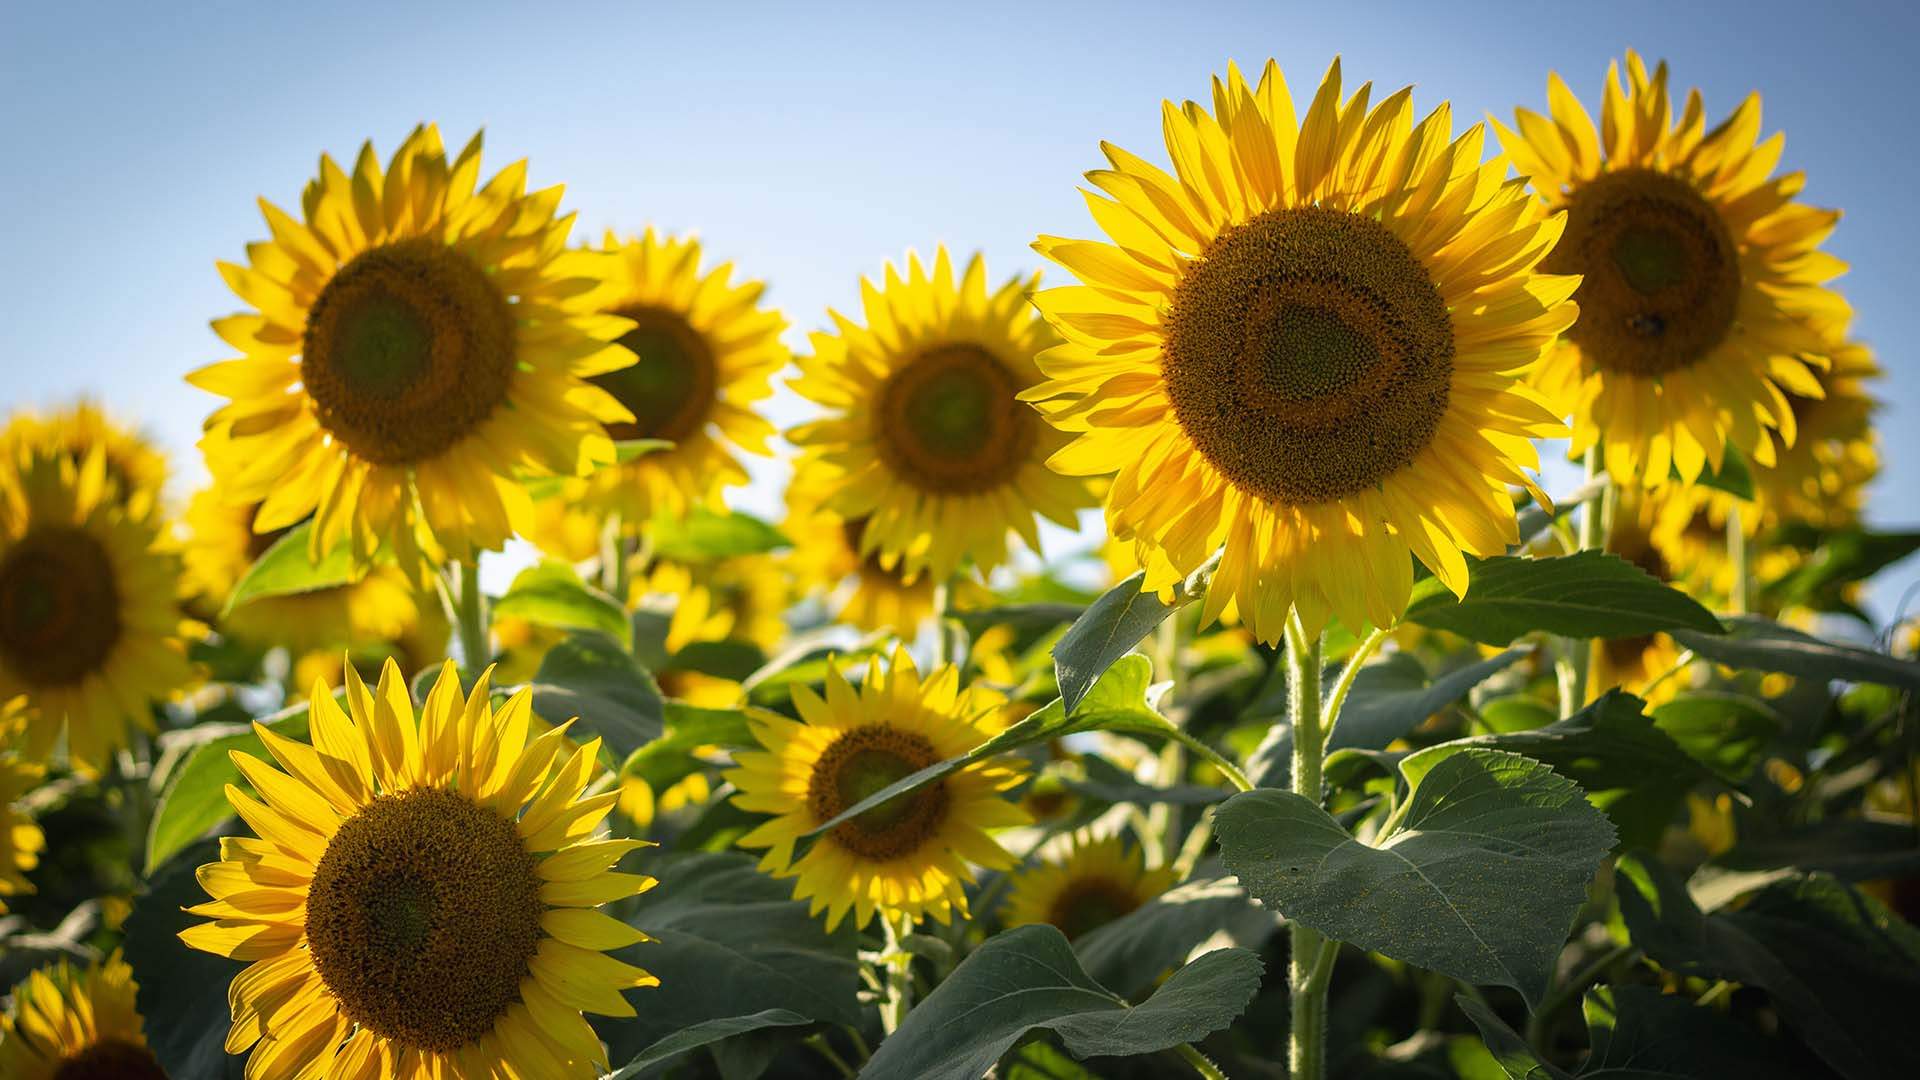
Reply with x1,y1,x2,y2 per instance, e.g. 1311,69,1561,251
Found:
874,344,1037,494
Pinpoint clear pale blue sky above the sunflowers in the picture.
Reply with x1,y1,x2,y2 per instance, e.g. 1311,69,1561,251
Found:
0,0,1920,615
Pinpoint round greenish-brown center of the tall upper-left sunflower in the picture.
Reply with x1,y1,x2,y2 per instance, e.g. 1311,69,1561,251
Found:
300,240,516,465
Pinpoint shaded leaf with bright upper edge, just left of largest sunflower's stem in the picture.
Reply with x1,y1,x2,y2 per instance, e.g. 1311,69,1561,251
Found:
1073,865,1277,997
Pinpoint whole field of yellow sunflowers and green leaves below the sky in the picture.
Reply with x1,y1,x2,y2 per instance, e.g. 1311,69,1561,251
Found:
0,33,1920,1080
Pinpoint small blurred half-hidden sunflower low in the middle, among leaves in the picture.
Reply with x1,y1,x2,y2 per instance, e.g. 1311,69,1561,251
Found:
1004,830,1177,942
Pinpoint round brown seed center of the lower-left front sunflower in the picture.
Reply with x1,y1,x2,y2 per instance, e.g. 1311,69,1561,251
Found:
307,788,545,1051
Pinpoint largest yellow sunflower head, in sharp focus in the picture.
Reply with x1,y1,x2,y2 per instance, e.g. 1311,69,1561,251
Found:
1023,61,1578,642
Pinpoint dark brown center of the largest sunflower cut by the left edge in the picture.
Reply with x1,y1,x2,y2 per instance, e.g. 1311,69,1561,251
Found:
0,527,121,686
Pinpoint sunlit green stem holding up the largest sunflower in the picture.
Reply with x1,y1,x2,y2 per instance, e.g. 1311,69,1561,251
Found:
1286,609,1338,1080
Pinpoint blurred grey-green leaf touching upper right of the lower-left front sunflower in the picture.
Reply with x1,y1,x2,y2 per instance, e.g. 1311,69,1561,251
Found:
532,632,666,761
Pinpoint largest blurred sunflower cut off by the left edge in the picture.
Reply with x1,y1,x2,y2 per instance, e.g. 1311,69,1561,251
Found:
0,446,192,773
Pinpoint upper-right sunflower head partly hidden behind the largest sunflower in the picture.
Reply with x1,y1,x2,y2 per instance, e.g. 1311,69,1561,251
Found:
1494,52,1849,486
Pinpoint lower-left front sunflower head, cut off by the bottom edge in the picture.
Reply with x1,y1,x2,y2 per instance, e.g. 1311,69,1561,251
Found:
180,661,659,1080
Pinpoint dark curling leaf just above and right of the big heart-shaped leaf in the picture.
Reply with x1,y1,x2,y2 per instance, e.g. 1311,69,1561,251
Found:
1400,690,1711,844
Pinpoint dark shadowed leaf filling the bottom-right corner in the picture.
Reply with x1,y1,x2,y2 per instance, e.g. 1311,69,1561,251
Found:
1619,857,1920,1080
